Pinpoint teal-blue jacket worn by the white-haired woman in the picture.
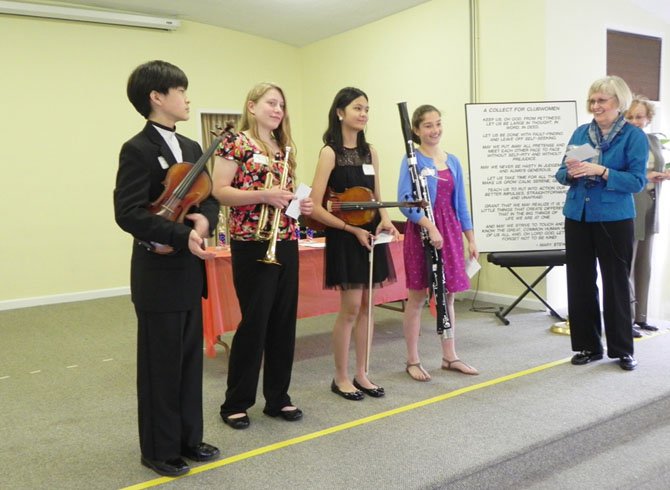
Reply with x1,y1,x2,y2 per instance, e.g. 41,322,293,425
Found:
556,123,649,222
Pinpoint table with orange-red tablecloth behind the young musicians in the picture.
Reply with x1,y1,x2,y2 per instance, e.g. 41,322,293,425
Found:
202,236,407,357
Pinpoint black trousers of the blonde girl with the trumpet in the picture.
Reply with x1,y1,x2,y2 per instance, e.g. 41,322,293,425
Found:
221,240,298,416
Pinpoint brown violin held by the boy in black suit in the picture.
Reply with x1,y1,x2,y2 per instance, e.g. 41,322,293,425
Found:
147,124,233,255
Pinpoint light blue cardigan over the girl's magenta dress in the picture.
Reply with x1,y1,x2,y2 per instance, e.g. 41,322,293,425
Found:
398,151,472,231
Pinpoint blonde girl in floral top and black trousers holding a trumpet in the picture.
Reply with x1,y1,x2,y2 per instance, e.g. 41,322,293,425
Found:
212,83,312,429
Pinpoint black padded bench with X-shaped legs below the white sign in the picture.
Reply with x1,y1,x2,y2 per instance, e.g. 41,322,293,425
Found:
487,250,565,325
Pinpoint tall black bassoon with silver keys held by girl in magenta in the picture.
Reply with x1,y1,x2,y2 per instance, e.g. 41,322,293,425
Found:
398,102,454,339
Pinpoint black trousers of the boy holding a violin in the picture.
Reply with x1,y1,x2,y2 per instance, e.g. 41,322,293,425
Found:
135,304,203,461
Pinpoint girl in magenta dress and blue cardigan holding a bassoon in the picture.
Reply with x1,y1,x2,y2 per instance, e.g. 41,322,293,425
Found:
398,105,479,381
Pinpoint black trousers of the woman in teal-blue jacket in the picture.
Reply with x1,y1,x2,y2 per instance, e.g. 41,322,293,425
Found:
565,219,633,358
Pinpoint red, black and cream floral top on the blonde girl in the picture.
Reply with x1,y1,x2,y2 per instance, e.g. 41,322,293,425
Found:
216,132,296,241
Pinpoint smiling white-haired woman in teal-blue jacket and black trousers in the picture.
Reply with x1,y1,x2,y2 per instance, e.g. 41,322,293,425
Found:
556,76,649,371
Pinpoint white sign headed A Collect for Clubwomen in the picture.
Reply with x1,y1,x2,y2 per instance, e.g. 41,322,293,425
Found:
465,101,577,252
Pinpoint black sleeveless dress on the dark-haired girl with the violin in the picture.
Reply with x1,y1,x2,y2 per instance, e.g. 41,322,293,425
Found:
324,148,396,290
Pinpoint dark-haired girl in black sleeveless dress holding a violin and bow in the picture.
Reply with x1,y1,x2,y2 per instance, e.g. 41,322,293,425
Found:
312,87,398,400
